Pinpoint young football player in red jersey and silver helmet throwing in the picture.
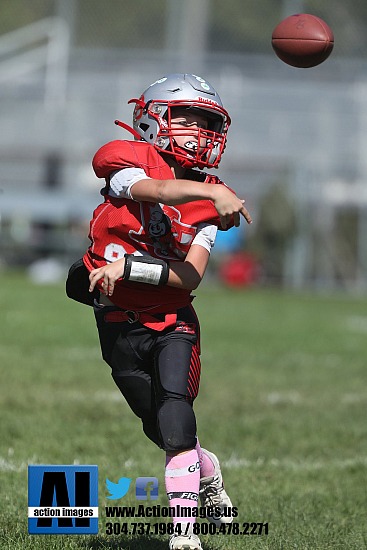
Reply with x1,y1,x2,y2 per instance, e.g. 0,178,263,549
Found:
68,74,251,550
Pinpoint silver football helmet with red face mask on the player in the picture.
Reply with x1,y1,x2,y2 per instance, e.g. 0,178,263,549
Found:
129,74,231,169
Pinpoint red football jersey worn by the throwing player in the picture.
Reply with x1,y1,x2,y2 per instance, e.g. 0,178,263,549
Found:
83,140,233,329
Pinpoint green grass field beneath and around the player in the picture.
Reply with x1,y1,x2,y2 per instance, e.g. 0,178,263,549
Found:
0,274,367,550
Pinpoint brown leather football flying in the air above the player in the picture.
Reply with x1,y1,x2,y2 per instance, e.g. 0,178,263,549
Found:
271,13,334,68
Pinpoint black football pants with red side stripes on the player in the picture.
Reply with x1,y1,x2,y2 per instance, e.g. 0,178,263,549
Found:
94,306,201,452
